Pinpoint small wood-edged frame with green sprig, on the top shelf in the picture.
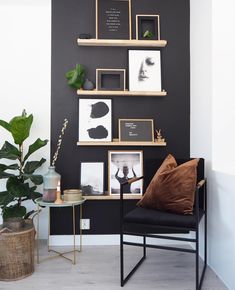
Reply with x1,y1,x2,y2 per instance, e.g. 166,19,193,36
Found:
136,14,161,40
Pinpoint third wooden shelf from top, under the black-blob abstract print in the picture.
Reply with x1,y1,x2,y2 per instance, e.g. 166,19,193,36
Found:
77,139,166,147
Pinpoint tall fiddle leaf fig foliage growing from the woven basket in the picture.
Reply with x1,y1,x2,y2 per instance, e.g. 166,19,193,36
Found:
0,110,48,220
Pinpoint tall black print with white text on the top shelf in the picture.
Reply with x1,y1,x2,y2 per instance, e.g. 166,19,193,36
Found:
96,0,131,39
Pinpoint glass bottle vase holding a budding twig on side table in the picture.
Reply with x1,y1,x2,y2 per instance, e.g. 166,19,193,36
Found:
42,166,61,202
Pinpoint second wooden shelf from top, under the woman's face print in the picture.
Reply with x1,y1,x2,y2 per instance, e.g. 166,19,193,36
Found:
77,90,167,97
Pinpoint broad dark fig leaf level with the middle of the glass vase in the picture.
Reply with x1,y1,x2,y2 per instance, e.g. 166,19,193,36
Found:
6,176,30,197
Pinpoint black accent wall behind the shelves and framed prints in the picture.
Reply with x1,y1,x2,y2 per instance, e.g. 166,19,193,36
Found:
51,0,190,234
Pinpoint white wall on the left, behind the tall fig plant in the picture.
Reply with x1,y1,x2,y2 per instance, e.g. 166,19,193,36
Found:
0,0,51,237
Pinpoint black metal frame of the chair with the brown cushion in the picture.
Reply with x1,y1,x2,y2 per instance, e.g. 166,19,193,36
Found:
120,160,207,290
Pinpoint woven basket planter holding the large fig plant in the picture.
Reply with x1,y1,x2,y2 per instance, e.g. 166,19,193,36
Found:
0,220,35,281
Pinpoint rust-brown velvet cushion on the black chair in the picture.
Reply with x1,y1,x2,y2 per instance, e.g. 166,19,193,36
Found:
137,155,199,214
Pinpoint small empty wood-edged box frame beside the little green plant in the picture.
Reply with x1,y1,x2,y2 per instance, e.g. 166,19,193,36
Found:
96,68,126,91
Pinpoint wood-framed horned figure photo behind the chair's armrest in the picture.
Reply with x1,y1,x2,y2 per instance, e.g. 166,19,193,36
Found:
108,150,143,195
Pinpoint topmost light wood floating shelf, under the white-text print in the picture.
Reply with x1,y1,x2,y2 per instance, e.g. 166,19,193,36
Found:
77,38,167,47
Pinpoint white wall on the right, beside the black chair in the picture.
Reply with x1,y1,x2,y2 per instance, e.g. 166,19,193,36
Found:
190,0,235,289
